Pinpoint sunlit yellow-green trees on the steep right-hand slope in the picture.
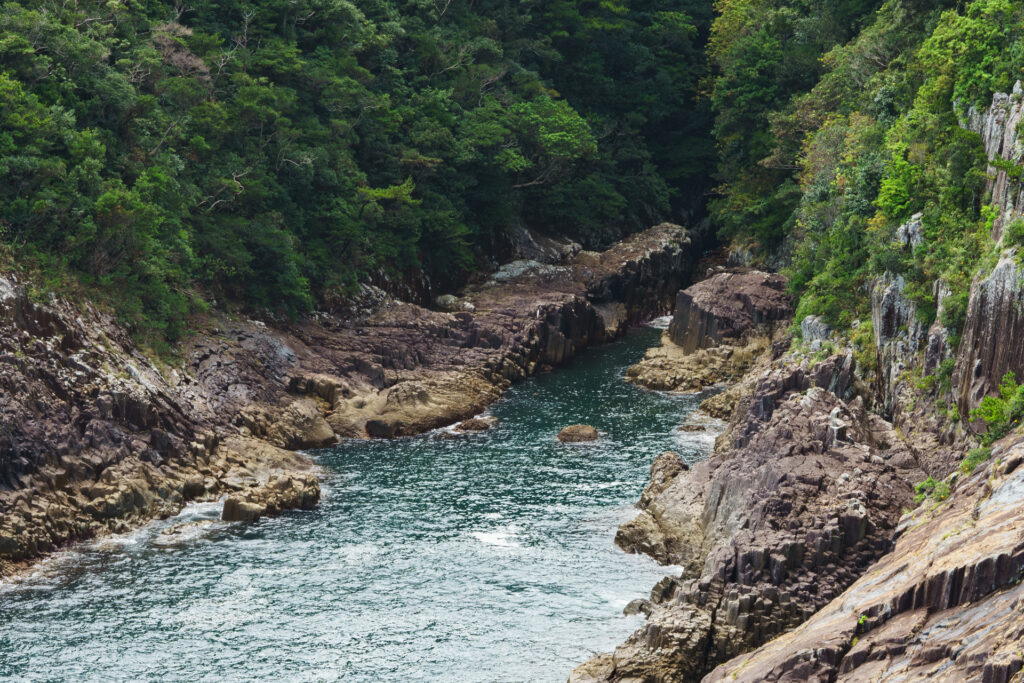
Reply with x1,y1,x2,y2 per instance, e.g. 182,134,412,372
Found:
709,0,1024,342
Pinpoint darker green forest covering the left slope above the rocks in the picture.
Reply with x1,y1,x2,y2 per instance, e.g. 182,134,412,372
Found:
0,0,714,340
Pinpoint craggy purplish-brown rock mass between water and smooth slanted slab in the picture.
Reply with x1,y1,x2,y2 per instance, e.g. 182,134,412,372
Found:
570,354,923,681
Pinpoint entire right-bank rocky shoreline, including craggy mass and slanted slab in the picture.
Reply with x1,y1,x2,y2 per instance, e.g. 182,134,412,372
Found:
569,264,1024,683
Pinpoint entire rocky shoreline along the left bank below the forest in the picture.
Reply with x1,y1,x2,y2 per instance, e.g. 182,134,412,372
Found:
0,224,693,577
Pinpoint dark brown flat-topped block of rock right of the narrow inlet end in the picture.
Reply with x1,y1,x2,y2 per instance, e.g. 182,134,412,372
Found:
669,270,793,353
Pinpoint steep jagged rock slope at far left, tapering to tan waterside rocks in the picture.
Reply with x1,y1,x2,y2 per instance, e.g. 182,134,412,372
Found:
0,278,321,575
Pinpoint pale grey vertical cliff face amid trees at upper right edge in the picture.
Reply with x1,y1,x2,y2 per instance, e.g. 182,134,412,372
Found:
966,81,1024,241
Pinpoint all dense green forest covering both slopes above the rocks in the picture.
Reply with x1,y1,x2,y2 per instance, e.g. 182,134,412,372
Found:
0,0,1024,348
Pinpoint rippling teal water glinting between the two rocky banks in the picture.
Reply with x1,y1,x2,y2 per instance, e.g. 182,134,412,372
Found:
0,329,701,681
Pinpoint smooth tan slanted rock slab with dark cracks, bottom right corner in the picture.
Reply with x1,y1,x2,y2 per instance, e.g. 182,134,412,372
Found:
706,437,1024,683
